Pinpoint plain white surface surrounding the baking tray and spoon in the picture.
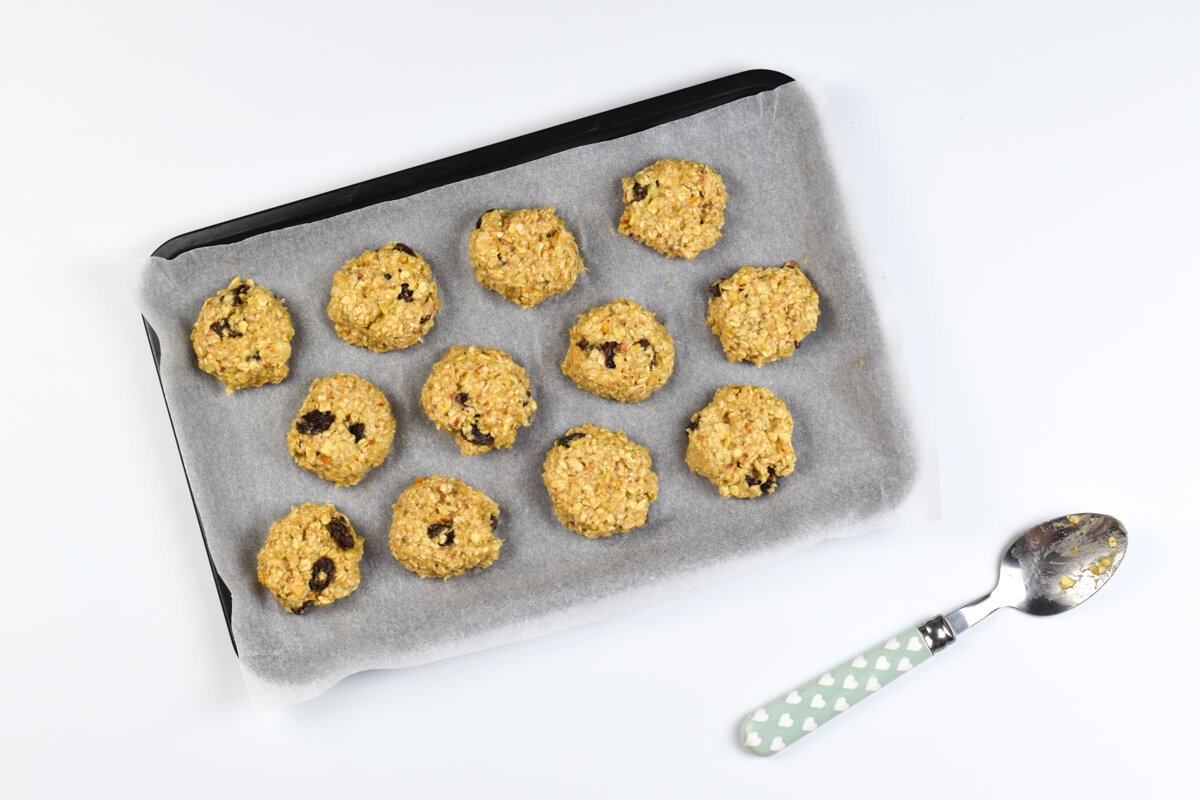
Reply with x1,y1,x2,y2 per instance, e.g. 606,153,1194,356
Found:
0,0,1200,798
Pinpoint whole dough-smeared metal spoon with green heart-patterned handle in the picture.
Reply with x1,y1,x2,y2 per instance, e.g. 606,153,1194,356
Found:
742,513,1126,756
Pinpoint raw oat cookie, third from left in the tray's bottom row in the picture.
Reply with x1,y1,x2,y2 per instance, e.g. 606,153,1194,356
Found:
541,422,659,539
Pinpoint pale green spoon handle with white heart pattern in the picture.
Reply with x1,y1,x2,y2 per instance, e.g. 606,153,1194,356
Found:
742,627,936,756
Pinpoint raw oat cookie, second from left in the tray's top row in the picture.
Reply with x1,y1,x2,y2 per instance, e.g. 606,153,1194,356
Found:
325,242,442,353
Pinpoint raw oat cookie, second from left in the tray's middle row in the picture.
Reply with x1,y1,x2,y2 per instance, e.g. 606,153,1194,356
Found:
421,347,538,456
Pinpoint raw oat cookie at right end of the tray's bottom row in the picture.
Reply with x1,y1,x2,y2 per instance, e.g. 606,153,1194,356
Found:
686,386,796,498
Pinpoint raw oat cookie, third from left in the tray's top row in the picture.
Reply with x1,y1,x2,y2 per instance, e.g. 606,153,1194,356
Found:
469,207,583,308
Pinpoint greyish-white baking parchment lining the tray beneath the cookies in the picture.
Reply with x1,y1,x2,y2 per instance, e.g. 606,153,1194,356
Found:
140,77,937,703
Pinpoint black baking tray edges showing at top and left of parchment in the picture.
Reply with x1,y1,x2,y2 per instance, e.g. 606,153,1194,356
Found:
142,70,793,652
